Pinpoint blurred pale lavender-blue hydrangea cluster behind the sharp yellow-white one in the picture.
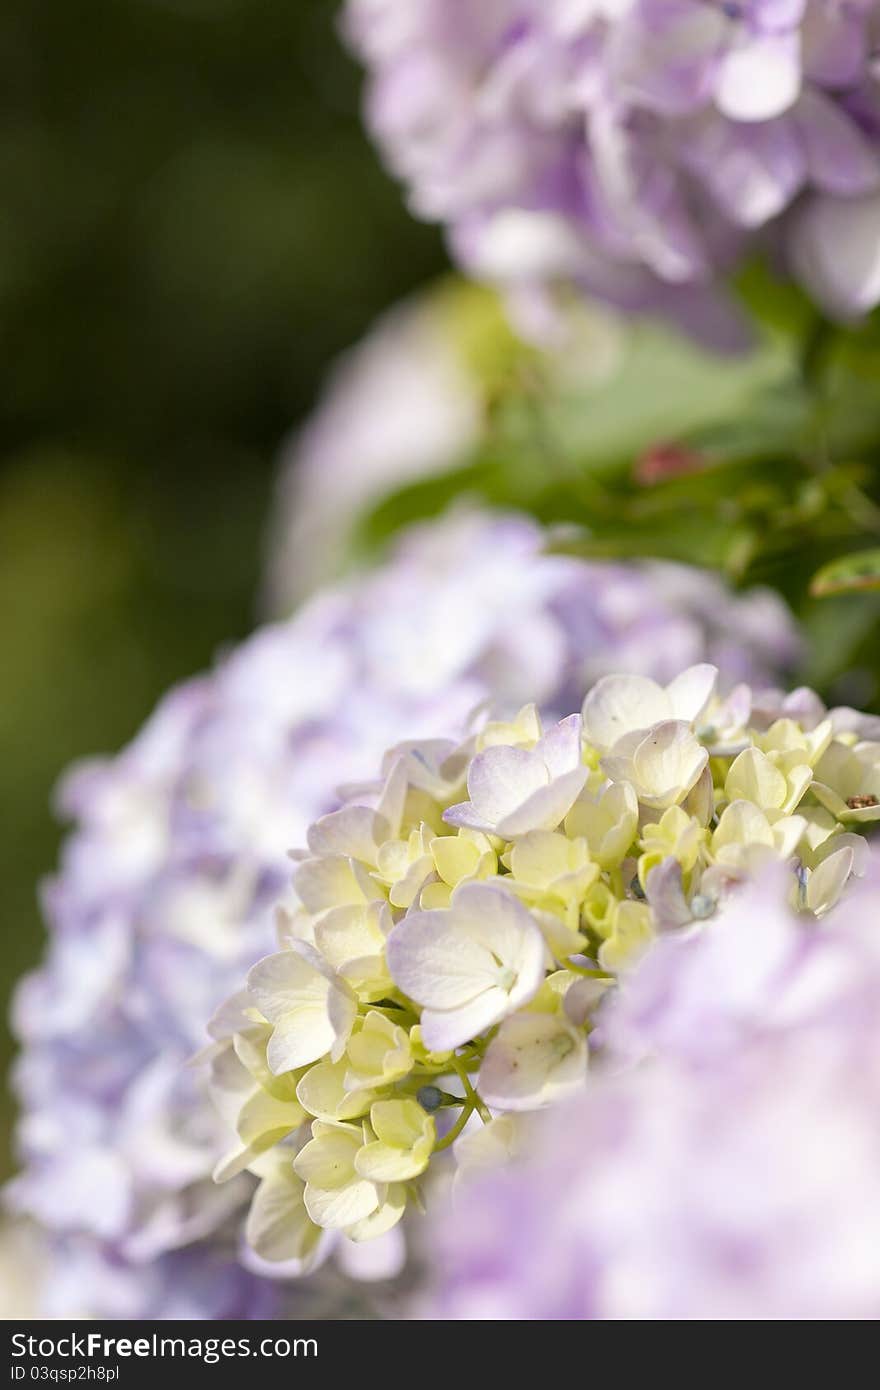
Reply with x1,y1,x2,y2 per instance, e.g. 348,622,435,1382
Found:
8,516,797,1318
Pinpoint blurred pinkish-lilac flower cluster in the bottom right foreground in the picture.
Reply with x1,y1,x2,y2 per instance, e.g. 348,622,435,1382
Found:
425,853,880,1319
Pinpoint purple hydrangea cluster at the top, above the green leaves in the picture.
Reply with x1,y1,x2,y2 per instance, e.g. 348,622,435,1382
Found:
346,0,880,339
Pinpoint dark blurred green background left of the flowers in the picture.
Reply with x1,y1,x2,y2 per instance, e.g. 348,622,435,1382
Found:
0,0,443,1173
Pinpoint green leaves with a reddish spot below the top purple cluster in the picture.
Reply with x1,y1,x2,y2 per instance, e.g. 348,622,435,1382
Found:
361,275,880,705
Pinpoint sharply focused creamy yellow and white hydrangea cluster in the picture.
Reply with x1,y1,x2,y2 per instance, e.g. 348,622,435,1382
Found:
213,664,880,1262
